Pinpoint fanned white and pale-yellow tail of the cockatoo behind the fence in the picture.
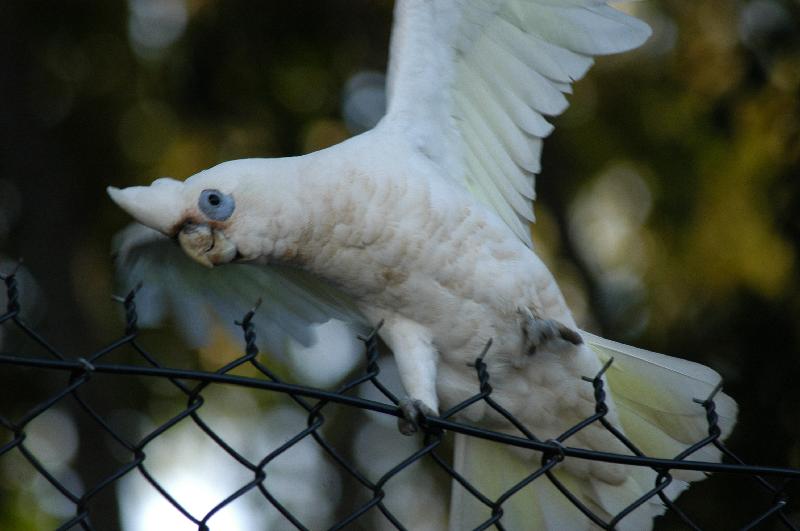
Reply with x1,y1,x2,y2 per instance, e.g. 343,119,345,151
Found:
450,332,737,531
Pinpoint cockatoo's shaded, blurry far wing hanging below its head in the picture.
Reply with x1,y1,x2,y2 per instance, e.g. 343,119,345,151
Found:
114,223,364,353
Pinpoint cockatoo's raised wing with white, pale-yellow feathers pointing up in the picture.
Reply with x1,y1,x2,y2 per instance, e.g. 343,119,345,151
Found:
384,0,650,245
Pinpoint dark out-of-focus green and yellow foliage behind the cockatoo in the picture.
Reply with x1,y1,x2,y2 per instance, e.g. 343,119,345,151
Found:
0,0,800,529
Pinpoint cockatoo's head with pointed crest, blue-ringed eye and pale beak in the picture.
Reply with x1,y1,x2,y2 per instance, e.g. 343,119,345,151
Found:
108,168,244,267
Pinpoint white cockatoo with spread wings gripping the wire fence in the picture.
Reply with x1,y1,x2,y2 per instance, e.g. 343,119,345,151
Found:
109,0,736,530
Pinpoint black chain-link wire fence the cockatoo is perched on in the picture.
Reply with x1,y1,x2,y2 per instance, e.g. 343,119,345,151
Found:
0,272,800,530
